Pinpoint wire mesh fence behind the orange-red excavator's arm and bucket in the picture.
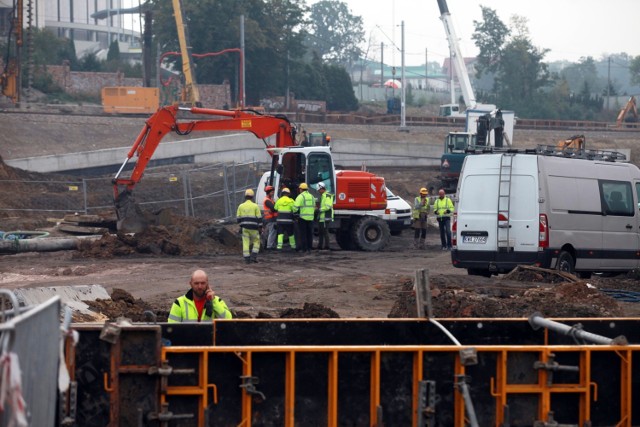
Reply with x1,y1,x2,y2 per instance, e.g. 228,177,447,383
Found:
0,161,262,219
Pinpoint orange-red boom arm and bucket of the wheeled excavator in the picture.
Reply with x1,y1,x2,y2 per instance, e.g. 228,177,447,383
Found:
113,105,297,231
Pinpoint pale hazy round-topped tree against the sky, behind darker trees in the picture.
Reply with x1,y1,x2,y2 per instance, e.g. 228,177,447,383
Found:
306,0,365,65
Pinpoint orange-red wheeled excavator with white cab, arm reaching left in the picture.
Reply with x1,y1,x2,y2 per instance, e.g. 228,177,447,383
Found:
113,105,390,251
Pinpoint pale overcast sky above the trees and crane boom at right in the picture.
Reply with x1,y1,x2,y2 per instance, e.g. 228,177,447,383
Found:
332,0,640,66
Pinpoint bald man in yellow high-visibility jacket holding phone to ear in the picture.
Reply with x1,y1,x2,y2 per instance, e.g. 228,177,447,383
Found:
167,270,232,323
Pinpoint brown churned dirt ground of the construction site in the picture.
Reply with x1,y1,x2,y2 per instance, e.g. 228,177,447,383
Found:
0,114,640,321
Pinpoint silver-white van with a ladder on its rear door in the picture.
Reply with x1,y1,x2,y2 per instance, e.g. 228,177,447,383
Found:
451,148,640,277
